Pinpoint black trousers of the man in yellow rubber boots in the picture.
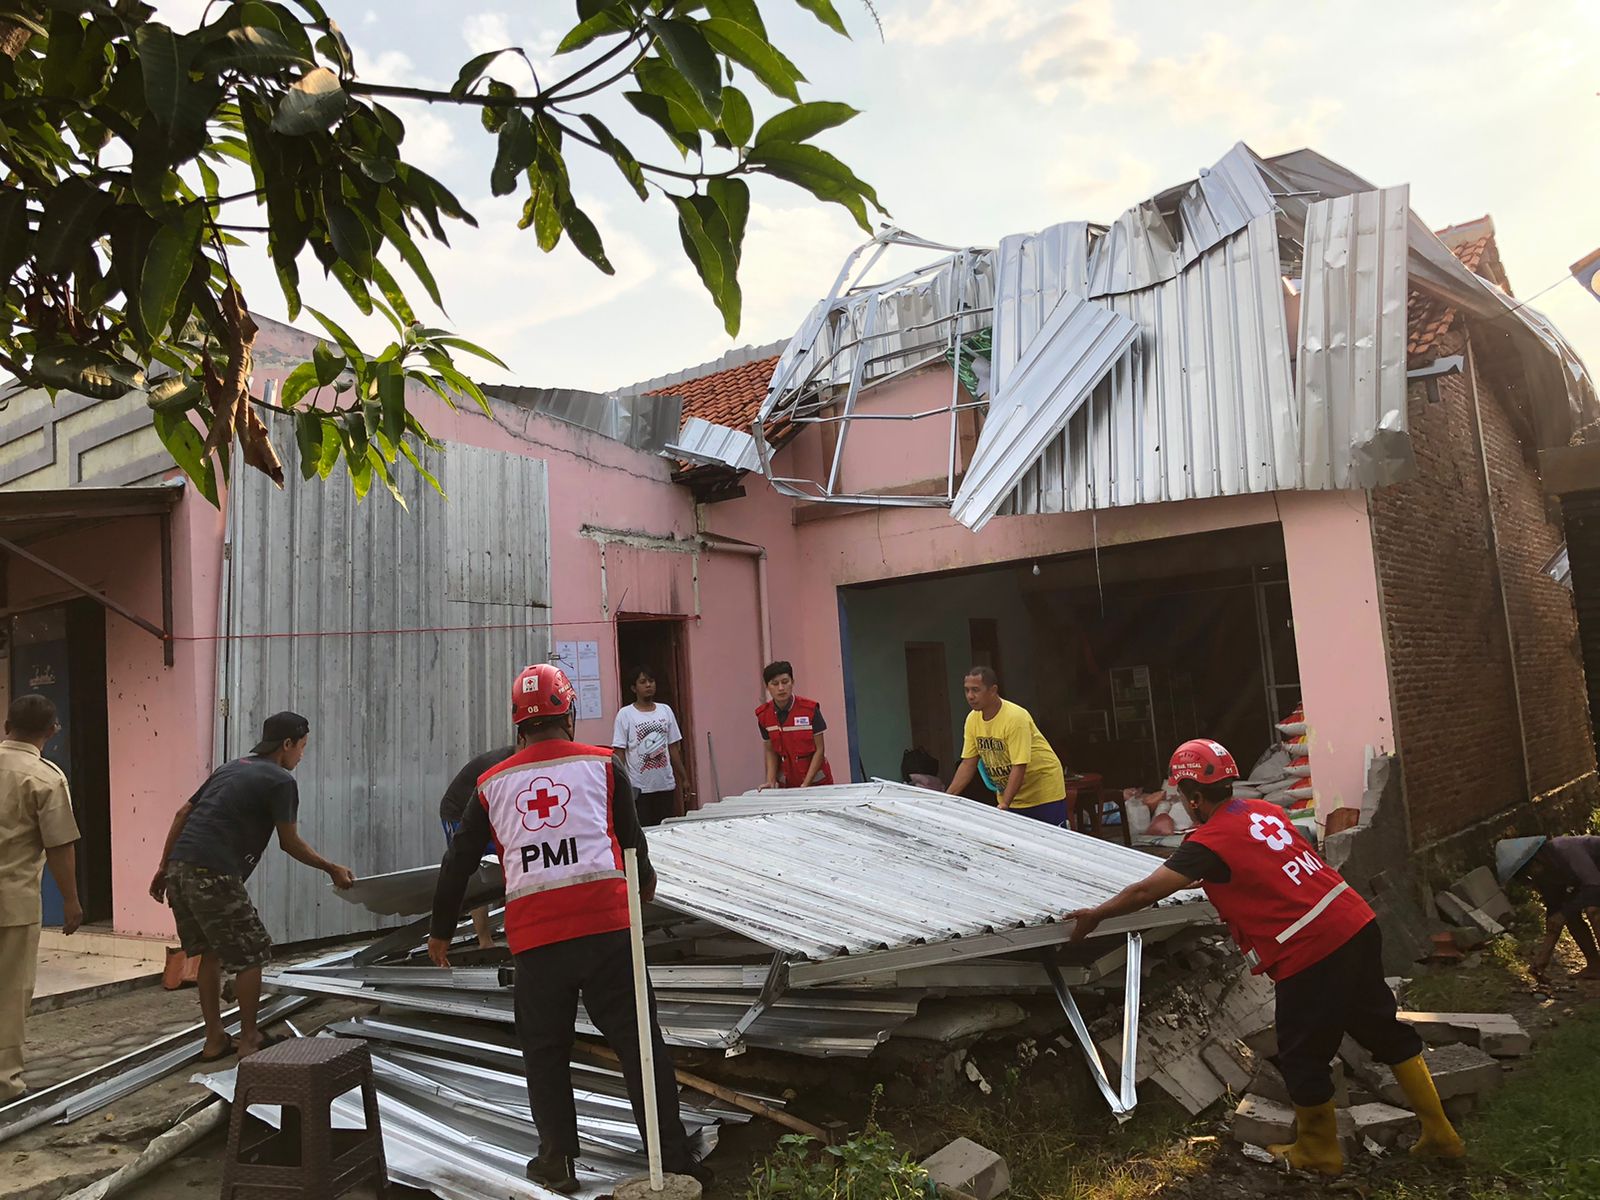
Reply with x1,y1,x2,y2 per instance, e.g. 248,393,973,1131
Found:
1277,922,1422,1107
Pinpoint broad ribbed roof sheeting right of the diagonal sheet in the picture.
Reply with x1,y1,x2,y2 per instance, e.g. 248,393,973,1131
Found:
1002,214,1301,514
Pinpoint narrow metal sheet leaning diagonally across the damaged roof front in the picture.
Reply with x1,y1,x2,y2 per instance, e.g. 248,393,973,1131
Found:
950,294,1139,533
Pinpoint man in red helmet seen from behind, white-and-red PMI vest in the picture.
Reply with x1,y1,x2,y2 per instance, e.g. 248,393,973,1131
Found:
427,662,710,1194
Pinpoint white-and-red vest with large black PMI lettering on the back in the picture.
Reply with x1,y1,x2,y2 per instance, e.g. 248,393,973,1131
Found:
478,741,627,954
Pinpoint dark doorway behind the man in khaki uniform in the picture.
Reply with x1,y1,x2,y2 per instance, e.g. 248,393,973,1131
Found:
8,600,112,926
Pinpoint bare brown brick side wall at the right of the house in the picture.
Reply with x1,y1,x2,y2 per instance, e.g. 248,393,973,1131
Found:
1371,334,1594,846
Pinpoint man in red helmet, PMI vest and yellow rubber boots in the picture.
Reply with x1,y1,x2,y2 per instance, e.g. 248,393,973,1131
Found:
1064,739,1464,1174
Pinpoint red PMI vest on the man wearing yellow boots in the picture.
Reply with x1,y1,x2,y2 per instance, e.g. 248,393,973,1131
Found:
1189,800,1373,979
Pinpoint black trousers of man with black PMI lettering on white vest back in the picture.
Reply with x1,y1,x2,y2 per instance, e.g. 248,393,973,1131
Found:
514,930,693,1171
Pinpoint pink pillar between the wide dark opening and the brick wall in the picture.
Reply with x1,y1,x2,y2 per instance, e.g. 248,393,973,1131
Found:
1278,491,1395,816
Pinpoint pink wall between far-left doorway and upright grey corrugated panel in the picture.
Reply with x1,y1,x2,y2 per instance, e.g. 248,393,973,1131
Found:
8,490,222,934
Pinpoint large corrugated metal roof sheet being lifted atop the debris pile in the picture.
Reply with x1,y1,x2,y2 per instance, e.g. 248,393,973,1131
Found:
650,782,1198,962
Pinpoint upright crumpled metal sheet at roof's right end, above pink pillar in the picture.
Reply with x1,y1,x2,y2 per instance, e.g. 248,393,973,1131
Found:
1294,184,1416,490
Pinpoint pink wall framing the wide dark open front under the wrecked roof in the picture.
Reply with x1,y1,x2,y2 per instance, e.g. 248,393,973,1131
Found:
726,371,1394,811
